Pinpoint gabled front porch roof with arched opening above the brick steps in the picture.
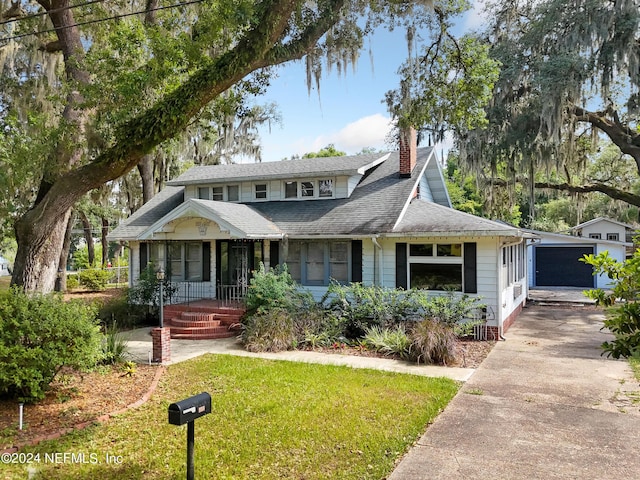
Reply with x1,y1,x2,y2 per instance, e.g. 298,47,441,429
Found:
139,198,284,240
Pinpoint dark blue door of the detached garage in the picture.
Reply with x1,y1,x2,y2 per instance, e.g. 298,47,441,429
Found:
536,246,595,288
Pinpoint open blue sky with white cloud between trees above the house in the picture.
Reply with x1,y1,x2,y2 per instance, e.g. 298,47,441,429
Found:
256,0,483,162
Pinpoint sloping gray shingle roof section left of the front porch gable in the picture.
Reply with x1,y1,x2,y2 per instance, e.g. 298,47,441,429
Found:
107,187,184,241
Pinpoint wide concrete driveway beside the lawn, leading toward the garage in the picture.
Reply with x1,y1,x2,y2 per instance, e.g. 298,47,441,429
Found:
389,306,640,480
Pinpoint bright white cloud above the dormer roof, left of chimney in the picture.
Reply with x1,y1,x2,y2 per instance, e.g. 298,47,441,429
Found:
306,113,391,154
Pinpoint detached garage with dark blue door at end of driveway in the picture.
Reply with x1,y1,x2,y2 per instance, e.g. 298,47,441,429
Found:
527,219,632,288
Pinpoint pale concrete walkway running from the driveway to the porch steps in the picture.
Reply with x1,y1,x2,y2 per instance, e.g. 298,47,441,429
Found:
122,328,475,382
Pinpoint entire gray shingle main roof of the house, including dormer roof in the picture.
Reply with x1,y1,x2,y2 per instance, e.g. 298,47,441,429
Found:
109,148,522,240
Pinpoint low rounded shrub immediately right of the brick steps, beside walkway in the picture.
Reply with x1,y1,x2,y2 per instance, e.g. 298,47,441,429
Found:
240,308,296,352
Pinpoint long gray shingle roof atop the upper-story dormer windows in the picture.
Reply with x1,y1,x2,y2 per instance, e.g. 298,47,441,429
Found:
167,153,389,185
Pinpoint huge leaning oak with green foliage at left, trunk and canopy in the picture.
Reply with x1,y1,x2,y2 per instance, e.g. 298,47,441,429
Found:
0,0,482,292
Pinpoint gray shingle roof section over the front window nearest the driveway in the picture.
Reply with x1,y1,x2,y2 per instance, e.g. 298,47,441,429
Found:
393,199,527,237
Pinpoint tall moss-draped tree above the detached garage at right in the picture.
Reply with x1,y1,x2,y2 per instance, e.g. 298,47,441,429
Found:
457,0,640,216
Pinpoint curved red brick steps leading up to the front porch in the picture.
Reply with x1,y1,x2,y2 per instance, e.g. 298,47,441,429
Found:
164,300,245,340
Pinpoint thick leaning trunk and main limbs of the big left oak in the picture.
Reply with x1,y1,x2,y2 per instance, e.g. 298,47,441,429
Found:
11,0,345,293
